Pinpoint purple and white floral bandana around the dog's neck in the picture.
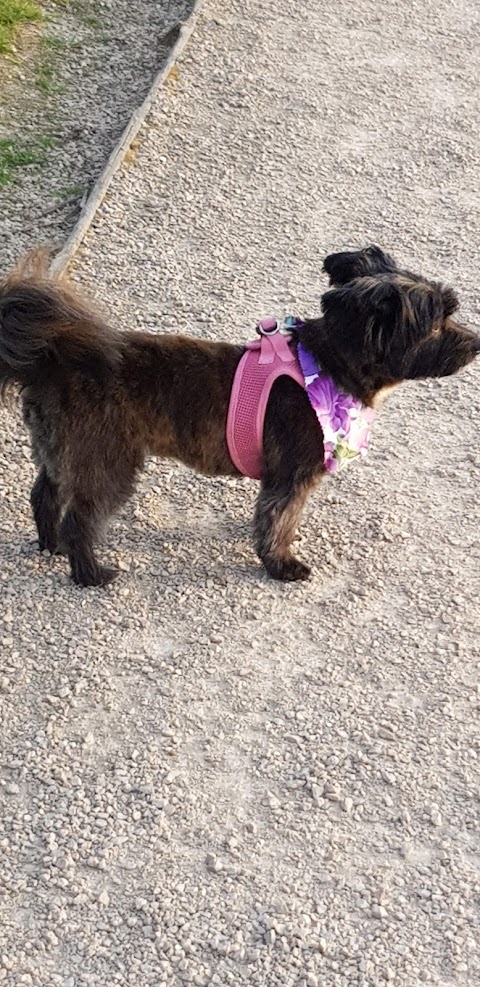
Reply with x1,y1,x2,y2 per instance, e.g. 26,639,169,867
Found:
284,316,375,473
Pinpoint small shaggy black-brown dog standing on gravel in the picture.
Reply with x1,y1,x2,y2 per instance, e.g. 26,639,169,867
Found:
0,247,480,586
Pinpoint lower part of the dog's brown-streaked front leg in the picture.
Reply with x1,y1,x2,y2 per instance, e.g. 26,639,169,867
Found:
254,474,315,582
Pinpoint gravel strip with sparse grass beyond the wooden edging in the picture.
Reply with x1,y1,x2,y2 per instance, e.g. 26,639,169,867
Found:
0,0,192,273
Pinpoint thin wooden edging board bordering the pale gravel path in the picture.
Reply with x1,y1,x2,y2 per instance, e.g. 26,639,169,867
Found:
50,0,205,277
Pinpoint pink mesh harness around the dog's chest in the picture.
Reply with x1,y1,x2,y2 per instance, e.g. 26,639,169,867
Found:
227,319,305,480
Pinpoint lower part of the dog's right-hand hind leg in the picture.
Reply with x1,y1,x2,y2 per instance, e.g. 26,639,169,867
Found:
60,495,117,586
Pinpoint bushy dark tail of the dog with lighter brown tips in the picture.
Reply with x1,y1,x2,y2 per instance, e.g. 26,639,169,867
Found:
0,250,121,395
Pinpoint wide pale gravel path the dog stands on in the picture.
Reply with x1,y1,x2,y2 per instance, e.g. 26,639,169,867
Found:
0,0,480,987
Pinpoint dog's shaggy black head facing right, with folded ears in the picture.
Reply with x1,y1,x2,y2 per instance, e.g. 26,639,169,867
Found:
316,247,480,388
